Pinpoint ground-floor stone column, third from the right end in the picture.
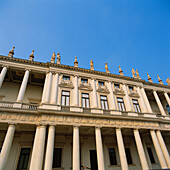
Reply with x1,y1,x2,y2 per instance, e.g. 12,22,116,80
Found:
134,129,149,170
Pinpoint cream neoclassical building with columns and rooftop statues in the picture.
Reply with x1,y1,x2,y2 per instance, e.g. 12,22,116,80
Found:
0,48,170,170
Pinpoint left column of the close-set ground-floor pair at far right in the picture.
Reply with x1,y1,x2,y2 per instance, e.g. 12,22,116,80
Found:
150,130,168,169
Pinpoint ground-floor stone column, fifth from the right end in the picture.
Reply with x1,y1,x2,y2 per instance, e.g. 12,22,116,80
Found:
95,127,105,170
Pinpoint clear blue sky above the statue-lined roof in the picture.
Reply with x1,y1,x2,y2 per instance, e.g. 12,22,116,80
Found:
0,0,170,84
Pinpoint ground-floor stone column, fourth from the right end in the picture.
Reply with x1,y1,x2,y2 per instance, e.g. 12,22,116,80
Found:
116,128,129,170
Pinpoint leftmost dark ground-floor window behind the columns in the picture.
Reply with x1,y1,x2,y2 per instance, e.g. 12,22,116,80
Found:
17,148,31,170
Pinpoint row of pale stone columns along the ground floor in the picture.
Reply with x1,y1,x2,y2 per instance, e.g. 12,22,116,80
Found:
0,124,170,170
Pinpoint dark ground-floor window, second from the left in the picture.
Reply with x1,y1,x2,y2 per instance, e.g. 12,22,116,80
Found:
53,148,62,168
